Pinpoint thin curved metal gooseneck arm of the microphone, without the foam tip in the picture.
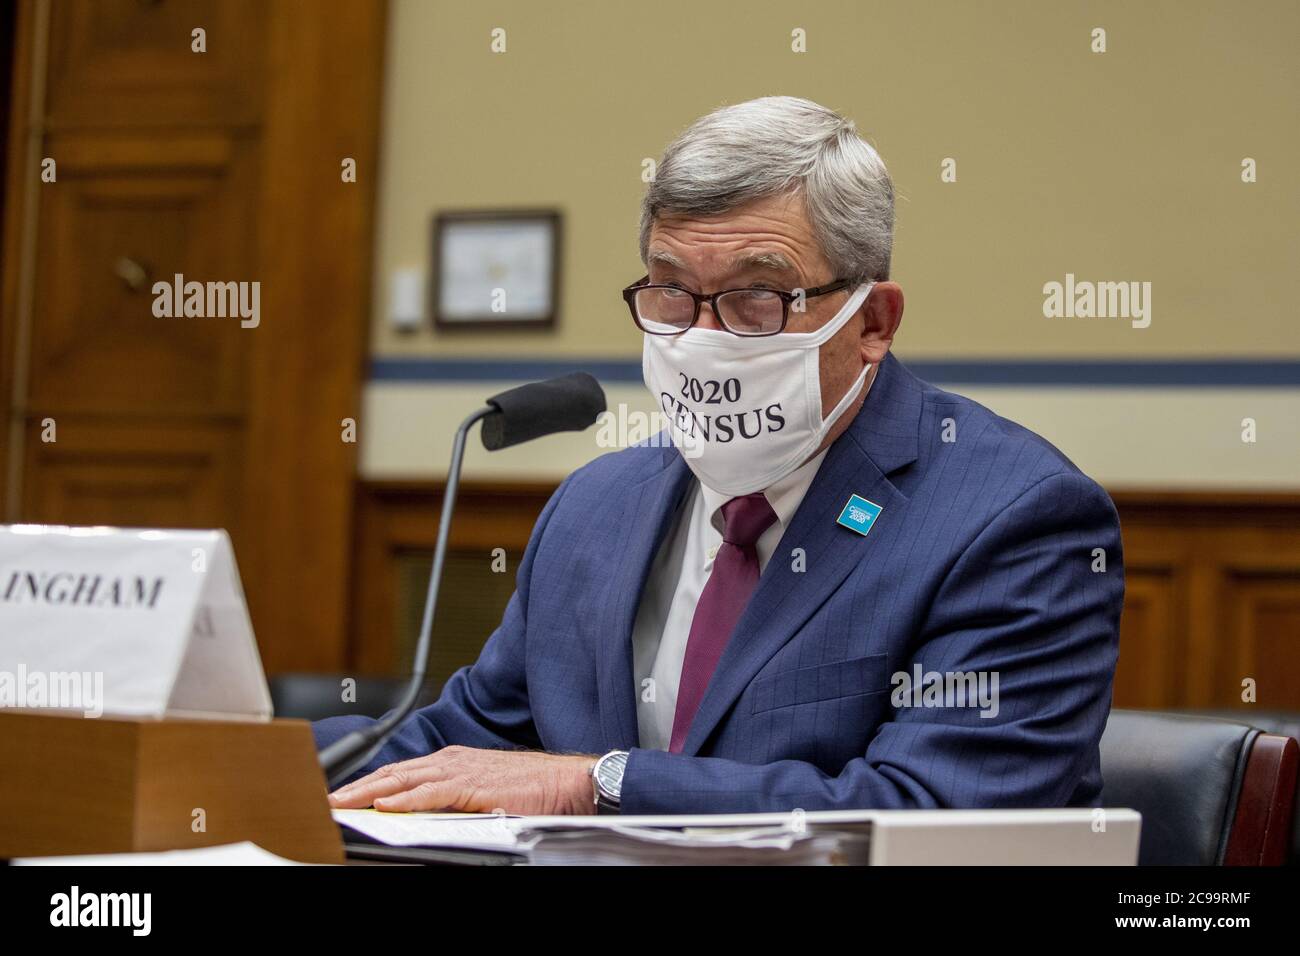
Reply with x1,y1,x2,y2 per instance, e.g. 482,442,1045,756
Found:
320,406,497,790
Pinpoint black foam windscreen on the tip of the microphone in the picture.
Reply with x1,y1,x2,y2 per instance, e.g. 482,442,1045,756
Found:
482,372,605,451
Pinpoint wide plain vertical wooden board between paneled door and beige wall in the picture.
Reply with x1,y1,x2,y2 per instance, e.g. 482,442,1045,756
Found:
238,0,385,671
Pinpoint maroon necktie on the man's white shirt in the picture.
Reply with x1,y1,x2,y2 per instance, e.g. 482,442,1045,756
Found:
668,492,776,753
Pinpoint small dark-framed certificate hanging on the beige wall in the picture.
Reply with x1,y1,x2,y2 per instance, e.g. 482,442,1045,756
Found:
429,209,560,329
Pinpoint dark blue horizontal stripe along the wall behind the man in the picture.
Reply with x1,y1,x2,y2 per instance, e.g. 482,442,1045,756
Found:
371,358,1300,389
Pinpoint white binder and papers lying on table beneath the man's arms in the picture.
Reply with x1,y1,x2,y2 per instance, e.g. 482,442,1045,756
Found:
334,808,1141,866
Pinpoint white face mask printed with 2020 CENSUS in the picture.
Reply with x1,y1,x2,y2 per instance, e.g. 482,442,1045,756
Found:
641,282,875,497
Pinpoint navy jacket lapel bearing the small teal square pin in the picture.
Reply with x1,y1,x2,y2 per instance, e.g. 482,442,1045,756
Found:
681,355,923,754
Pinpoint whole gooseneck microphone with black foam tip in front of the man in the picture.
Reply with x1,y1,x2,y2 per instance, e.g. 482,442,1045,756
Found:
317,372,606,791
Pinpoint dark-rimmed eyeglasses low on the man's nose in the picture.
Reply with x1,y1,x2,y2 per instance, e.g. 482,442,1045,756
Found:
623,276,850,337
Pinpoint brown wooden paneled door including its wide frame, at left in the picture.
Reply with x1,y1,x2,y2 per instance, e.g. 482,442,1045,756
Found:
0,0,385,671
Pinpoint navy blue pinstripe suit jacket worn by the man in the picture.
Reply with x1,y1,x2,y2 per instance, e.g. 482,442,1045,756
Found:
313,356,1123,813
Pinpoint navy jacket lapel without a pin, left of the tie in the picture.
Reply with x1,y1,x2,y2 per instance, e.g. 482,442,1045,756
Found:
595,447,692,749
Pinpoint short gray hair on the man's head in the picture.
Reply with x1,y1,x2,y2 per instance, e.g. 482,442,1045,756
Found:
641,96,893,282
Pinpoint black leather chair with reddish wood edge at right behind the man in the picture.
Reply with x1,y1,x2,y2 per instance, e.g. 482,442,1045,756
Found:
1101,710,1300,866
